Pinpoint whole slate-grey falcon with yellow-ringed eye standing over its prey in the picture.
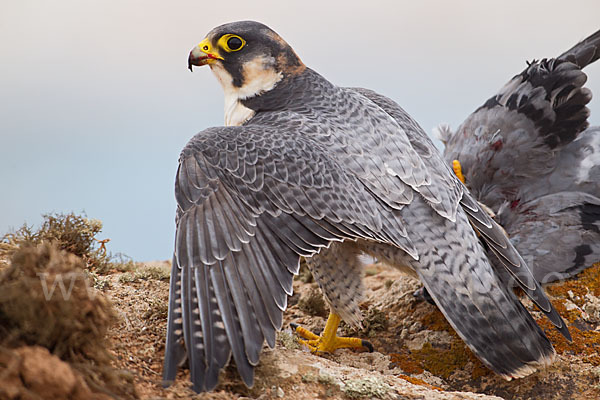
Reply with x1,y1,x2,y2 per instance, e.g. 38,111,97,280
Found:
163,21,570,392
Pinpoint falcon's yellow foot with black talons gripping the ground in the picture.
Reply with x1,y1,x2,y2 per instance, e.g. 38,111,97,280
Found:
290,313,373,353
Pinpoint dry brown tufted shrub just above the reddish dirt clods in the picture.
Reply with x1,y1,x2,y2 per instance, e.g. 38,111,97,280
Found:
0,242,136,398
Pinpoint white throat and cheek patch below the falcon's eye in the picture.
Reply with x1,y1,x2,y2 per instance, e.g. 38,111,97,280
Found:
210,57,283,126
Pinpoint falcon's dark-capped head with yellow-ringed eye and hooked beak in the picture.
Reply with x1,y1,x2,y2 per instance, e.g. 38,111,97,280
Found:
188,21,306,100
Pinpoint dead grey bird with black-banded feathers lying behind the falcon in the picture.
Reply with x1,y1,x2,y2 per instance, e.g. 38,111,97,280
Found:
441,31,600,282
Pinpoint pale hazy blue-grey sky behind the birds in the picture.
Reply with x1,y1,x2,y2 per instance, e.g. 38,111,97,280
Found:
0,0,600,261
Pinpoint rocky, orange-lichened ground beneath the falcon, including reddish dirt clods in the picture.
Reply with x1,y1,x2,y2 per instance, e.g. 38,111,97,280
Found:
0,242,600,399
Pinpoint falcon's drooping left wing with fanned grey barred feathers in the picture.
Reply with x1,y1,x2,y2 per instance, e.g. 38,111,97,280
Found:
164,125,416,391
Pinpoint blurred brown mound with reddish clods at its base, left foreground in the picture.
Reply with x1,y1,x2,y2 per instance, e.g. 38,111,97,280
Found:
0,243,136,398
